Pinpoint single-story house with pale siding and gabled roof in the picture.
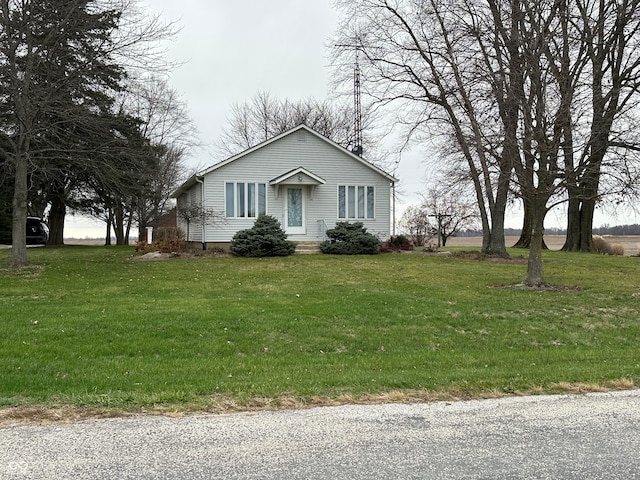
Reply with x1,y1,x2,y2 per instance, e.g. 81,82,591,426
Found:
173,125,396,246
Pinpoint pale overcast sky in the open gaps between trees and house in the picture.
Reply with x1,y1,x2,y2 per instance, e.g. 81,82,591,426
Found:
65,0,639,238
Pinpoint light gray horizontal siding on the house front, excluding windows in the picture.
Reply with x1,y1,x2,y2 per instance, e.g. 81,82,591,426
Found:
198,130,391,242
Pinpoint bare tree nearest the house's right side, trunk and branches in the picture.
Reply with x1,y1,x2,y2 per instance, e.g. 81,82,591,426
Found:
334,0,518,255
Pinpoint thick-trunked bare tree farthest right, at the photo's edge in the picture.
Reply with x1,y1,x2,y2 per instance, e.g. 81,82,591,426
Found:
559,0,640,252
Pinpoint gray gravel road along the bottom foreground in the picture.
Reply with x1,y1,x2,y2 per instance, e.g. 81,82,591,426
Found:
0,390,640,480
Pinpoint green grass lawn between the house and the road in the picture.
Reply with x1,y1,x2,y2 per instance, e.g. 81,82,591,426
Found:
0,246,640,411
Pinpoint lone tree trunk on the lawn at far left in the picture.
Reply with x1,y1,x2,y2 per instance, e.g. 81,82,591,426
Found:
9,153,29,268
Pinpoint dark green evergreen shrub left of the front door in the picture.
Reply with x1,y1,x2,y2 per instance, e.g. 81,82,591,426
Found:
230,214,296,257
